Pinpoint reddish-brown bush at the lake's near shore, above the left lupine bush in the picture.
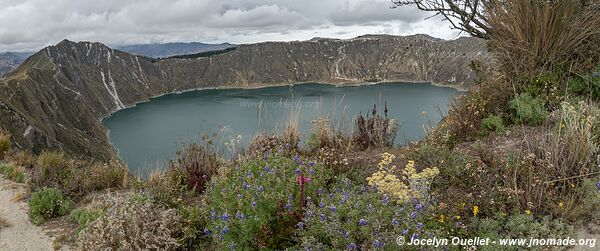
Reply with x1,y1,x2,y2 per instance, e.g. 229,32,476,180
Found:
169,144,220,193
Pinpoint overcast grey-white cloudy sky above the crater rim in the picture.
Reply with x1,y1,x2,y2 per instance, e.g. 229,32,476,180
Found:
0,0,458,51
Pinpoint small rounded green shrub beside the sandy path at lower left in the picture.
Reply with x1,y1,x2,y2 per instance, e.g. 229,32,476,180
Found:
29,188,71,225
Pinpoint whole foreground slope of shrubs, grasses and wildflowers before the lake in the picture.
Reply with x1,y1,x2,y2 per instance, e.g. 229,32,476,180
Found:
0,0,600,250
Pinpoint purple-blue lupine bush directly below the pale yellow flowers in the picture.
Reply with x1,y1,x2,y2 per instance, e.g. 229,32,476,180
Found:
296,179,440,250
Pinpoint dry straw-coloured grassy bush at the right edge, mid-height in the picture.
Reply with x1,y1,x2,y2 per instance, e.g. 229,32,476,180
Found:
511,102,600,220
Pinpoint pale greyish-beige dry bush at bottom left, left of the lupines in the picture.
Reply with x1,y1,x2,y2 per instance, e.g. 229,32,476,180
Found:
77,194,178,250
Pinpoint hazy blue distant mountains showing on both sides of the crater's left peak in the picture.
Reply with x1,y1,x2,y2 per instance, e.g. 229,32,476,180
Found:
0,42,235,76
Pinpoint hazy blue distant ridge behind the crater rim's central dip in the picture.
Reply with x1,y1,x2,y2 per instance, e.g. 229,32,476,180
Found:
115,42,235,58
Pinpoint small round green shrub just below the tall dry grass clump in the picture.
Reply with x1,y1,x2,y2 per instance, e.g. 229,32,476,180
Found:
509,93,548,126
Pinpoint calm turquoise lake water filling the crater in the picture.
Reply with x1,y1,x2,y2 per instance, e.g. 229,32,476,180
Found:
103,83,459,175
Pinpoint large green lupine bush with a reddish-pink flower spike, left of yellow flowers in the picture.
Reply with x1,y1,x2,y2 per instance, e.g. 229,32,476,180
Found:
205,153,329,250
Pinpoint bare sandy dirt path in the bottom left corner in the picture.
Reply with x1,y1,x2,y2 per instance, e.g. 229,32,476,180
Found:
0,175,65,251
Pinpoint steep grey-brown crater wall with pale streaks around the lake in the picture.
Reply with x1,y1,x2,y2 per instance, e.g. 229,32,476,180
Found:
0,35,489,160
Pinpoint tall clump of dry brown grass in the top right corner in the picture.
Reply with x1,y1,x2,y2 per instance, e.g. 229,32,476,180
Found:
488,0,600,82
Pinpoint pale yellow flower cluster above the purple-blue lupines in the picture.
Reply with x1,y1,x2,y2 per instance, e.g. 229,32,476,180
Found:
367,152,439,203
